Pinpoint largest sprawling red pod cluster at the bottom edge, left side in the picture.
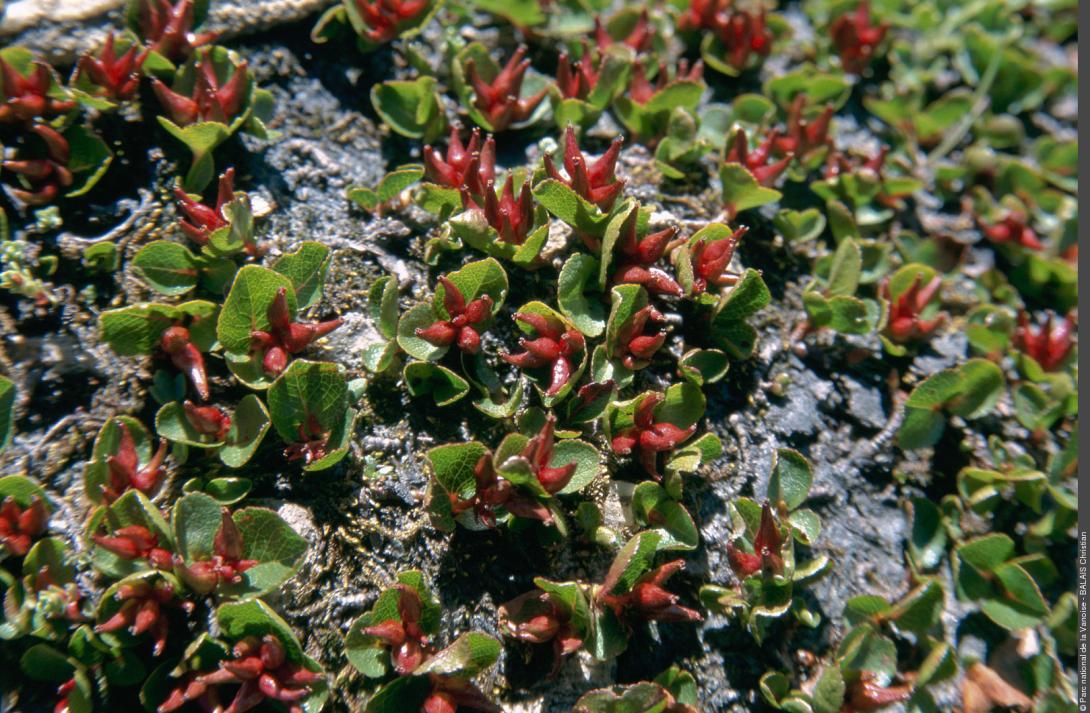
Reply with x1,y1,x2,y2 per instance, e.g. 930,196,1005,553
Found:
168,633,322,713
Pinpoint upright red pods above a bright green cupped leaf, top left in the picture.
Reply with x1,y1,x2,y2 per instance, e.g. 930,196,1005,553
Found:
152,51,251,126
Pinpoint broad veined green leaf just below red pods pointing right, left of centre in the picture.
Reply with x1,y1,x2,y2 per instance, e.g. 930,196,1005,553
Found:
268,359,349,443
